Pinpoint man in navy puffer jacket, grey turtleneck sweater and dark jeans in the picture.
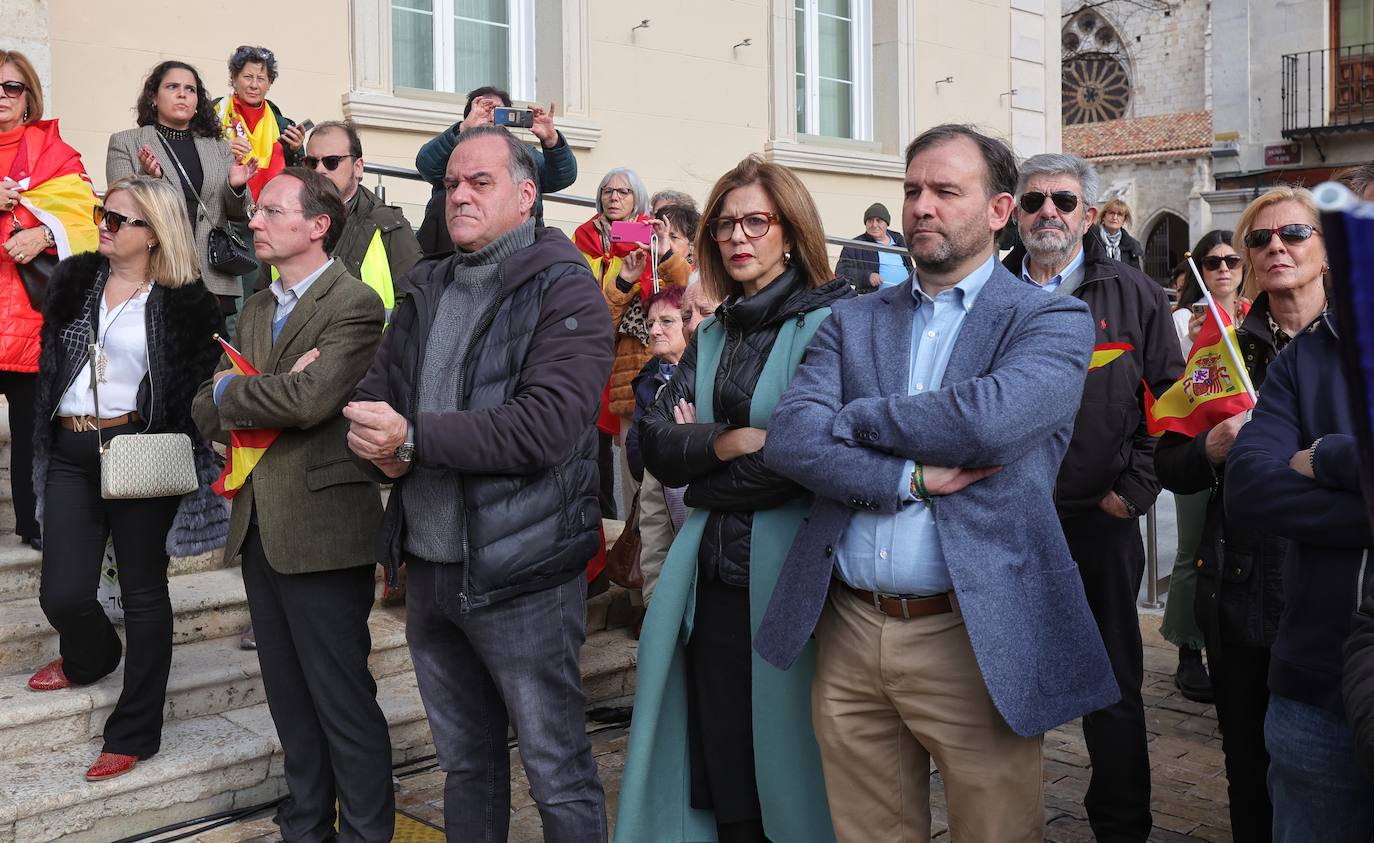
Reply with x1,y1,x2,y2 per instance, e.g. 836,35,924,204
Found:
344,126,613,842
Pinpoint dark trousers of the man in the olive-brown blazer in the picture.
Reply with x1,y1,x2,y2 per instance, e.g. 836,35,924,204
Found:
243,524,396,843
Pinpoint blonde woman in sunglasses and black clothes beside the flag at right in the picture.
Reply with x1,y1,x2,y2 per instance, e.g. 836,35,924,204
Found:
1156,187,1330,840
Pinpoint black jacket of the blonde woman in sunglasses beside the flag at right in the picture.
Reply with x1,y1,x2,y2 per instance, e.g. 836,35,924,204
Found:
1154,294,1287,658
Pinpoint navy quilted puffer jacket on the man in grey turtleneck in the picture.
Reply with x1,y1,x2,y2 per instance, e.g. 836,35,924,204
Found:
354,228,611,611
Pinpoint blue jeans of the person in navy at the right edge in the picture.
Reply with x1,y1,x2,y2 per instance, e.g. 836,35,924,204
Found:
1264,693,1374,843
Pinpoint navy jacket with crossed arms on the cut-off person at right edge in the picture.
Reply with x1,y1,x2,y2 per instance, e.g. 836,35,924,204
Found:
1226,313,1374,714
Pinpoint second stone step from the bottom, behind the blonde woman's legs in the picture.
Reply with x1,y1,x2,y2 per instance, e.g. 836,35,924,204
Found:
0,608,411,752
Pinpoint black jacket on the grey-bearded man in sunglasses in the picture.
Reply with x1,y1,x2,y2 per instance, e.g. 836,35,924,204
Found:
1003,232,1183,518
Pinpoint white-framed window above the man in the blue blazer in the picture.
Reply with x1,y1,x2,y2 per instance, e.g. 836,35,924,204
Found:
793,0,872,140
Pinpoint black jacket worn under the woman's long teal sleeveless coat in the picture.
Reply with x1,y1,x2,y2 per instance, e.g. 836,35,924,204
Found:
640,270,852,586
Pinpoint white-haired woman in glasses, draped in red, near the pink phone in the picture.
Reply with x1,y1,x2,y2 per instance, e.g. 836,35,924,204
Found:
573,168,691,518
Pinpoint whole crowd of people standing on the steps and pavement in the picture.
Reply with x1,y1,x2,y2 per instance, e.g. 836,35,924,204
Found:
0,47,1374,843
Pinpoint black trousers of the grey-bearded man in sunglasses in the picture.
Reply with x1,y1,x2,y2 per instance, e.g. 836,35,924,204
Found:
1062,511,1153,843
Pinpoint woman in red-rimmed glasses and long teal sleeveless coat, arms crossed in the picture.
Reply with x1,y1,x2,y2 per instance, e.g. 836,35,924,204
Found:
616,157,853,843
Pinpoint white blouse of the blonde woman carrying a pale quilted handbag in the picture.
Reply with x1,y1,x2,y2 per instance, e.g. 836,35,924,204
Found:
58,287,148,419
